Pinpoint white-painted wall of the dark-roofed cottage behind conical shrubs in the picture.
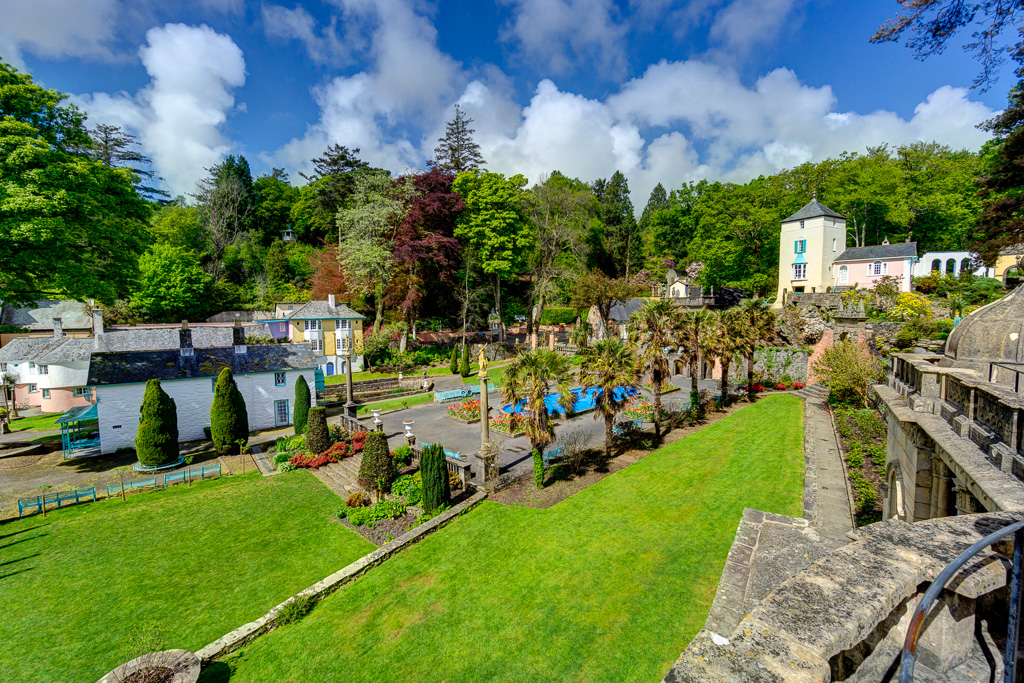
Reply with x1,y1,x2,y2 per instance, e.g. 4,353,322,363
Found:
95,370,314,454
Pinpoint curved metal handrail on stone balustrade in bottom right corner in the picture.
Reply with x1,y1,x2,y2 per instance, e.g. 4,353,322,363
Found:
899,521,1024,683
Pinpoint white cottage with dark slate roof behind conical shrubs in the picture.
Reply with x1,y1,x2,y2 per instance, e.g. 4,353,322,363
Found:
88,325,316,454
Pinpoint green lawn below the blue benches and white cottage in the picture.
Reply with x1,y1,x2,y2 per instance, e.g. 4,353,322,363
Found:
0,472,373,681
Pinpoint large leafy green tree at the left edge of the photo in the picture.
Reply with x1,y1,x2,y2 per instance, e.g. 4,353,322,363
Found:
0,61,150,305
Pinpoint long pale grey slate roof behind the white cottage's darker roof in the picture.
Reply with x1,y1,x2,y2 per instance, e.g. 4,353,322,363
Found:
0,325,270,364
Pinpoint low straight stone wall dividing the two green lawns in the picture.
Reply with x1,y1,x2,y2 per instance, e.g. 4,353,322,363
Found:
196,490,487,665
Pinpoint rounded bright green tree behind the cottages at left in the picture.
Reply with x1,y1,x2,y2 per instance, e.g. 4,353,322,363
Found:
132,244,210,323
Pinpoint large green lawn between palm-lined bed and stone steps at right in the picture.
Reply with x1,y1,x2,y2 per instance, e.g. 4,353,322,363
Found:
202,395,804,683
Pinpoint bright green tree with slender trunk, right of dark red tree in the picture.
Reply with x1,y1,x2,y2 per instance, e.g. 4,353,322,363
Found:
452,170,535,342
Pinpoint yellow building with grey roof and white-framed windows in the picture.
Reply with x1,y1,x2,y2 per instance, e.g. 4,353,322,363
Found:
260,294,367,375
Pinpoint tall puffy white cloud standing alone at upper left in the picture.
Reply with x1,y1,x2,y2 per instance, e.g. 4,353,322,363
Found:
77,24,246,195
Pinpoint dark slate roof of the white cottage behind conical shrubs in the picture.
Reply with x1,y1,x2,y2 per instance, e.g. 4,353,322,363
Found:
87,344,316,386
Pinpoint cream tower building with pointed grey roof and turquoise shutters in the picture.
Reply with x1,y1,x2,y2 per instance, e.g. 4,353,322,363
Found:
774,198,846,308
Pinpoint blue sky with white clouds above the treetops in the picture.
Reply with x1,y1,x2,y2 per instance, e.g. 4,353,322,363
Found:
0,0,1013,211
